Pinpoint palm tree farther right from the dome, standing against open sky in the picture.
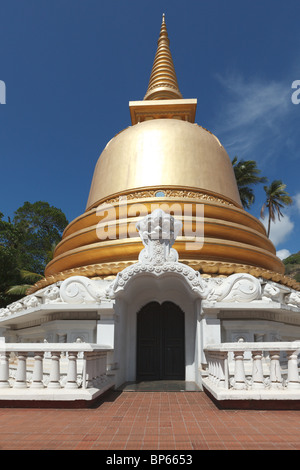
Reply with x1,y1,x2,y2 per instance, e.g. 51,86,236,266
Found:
260,180,293,237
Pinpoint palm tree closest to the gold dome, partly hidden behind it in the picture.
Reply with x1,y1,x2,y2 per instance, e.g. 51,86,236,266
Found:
231,157,268,209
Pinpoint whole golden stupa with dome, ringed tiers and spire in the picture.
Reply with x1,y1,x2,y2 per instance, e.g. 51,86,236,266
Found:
34,16,297,289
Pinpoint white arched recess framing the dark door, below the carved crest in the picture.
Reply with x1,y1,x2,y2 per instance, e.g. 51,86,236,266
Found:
115,273,201,383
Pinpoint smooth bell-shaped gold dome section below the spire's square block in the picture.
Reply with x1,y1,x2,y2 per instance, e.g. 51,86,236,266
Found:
86,119,241,210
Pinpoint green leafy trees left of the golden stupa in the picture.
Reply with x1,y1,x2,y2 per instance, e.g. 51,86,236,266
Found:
0,201,68,307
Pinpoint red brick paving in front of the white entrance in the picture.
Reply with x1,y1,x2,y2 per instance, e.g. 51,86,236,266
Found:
0,391,300,450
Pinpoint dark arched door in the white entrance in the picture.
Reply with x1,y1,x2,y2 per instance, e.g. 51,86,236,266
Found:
136,302,185,381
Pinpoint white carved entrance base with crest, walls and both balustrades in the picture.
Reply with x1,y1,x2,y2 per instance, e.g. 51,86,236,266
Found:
0,209,300,401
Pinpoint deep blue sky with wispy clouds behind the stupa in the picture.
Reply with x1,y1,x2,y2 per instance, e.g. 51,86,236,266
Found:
0,0,300,256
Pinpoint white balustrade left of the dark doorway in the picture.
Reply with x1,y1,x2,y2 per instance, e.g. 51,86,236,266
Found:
0,343,111,392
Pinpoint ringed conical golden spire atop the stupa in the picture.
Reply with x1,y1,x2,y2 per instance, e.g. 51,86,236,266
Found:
144,14,182,100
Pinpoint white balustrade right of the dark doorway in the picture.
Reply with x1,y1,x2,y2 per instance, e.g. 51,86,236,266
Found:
203,341,300,400
